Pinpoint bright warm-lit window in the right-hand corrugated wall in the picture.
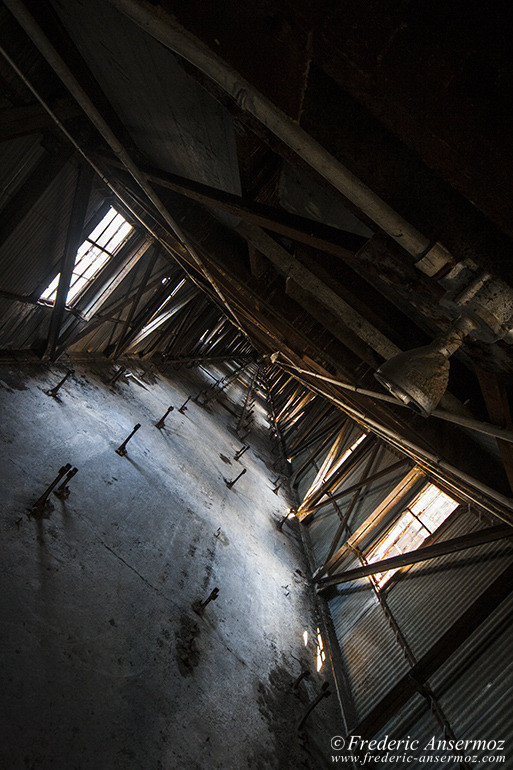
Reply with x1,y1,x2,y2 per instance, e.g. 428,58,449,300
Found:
366,483,458,587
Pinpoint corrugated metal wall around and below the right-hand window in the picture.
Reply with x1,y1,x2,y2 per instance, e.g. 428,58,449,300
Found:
284,408,513,756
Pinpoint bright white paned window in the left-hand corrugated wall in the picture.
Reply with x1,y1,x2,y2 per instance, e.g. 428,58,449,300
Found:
40,206,133,305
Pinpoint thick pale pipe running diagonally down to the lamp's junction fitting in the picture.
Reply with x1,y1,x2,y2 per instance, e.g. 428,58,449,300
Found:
108,0,431,258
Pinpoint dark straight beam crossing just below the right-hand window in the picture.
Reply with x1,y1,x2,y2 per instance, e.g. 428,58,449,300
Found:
316,524,513,591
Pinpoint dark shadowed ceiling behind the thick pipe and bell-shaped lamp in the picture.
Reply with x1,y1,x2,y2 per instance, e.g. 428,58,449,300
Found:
0,0,513,508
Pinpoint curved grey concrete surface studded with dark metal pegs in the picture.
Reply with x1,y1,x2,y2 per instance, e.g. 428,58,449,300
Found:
0,362,341,770
